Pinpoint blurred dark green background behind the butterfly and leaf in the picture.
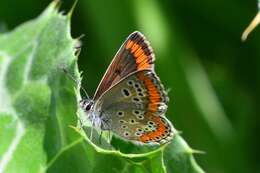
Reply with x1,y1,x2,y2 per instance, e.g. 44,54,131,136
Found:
0,0,260,173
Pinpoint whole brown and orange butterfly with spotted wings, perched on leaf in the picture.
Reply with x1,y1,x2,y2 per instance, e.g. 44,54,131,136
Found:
79,31,174,144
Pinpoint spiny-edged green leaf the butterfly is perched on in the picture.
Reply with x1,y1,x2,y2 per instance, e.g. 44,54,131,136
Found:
0,1,206,173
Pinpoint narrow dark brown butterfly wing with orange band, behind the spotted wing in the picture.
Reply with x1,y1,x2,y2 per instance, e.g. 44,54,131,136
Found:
93,31,154,100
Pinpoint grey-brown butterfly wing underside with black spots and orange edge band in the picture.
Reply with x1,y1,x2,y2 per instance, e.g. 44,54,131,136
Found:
95,70,173,143
